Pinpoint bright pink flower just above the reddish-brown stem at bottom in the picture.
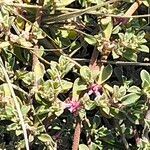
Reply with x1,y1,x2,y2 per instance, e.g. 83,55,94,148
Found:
65,101,81,113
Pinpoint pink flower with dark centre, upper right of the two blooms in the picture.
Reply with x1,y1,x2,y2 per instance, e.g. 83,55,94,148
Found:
88,84,102,96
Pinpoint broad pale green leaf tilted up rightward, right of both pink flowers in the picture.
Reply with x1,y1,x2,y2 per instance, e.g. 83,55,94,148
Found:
121,93,140,105
